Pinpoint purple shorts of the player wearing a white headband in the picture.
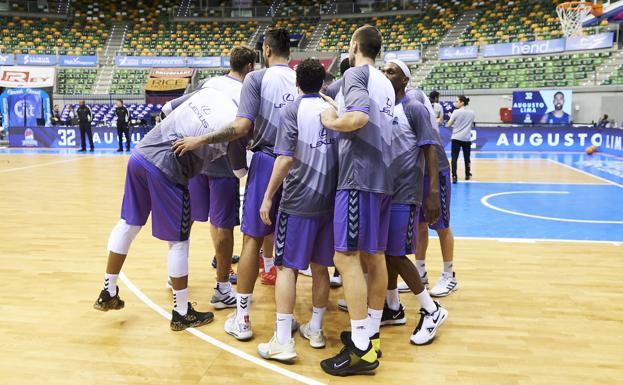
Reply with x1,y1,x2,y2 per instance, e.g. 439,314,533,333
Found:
385,203,420,257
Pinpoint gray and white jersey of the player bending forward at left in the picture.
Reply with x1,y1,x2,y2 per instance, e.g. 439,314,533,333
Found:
136,88,236,185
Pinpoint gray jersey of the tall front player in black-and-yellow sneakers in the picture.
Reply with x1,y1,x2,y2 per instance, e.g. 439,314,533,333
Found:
337,65,394,194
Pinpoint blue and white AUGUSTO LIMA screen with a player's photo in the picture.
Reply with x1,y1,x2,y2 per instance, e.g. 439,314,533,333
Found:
512,90,573,124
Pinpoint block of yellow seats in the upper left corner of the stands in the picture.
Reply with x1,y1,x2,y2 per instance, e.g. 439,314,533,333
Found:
0,16,110,55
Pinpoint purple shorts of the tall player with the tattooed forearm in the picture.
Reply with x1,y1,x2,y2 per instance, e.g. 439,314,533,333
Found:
240,151,281,237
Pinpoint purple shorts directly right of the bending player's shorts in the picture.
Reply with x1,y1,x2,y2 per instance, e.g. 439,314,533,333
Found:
188,174,240,229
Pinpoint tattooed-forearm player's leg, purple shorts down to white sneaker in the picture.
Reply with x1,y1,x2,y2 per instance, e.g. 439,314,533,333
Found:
224,152,281,340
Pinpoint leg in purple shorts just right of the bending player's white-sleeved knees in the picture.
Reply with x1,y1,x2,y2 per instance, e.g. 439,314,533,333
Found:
208,178,240,309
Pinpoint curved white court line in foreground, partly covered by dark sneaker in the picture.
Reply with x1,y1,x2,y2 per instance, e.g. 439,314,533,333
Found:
119,272,324,385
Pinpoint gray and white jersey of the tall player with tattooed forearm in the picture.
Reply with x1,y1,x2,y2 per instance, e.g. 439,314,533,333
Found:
237,64,297,155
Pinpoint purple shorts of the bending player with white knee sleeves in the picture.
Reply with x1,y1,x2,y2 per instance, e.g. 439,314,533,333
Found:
121,152,192,242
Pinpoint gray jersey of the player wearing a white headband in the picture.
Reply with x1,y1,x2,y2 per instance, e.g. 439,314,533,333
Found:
391,96,439,205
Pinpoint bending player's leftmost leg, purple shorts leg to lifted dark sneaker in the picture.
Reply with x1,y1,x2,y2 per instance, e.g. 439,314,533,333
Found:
94,157,151,311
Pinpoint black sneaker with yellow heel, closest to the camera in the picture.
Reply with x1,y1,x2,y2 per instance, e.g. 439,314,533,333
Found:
320,342,379,377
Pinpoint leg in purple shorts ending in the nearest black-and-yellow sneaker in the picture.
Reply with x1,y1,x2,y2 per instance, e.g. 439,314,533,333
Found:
320,190,378,375
